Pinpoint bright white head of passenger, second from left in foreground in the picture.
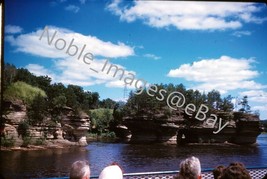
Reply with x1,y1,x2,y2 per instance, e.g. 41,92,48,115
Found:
98,163,123,179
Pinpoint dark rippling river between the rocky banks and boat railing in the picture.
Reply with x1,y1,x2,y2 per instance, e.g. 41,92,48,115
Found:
0,134,267,178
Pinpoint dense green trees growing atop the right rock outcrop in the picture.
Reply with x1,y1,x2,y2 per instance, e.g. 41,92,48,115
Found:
123,84,238,117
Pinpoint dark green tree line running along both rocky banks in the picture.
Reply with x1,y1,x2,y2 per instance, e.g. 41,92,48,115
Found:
3,64,255,136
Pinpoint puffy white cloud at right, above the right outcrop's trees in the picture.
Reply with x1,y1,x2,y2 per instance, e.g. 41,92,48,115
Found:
168,56,267,94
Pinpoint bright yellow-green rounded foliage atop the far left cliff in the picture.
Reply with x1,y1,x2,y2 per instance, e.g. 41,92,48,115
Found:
4,81,46,105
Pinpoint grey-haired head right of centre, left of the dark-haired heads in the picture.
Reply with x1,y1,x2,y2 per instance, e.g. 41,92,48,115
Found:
179,156,201,179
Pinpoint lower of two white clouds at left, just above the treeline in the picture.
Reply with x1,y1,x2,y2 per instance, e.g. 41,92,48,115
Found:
25,58,140,89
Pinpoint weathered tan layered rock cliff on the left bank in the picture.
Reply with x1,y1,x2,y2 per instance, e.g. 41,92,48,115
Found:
2,100,90,146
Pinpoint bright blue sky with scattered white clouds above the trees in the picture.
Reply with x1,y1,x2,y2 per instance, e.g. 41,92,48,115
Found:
4,0,267,119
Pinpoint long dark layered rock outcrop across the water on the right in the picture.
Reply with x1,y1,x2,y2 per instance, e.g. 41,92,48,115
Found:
124,111,262,145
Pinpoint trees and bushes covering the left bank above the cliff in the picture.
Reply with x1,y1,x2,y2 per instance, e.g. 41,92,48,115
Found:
3,63,116,134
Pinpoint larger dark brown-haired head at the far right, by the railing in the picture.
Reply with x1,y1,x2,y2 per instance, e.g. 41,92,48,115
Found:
219,163,251,179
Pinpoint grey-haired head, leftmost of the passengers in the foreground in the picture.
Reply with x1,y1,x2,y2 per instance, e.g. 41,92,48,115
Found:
70,161,90,179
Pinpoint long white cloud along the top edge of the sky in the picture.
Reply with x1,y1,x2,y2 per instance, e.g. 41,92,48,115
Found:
107,0,267,30
